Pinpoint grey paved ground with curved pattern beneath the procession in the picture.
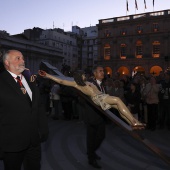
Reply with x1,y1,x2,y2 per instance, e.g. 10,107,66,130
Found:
0,118,170,170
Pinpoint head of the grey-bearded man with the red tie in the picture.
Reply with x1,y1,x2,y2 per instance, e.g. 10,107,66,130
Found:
5,50,25,75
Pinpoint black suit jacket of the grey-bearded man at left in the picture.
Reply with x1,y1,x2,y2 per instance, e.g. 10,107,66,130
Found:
0,71,48,152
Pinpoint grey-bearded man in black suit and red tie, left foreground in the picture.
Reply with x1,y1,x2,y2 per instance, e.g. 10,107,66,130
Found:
0,50,48,170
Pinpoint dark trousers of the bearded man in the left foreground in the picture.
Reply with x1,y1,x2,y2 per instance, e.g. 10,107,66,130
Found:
3,145,41,170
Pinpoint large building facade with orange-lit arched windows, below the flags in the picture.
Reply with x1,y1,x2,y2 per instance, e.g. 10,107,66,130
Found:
97,10,170,76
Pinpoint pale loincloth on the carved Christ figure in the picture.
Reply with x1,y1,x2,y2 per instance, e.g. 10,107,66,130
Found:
91,93,111,110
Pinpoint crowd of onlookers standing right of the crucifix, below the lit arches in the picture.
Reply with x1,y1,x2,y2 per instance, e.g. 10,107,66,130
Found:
106,70,170,131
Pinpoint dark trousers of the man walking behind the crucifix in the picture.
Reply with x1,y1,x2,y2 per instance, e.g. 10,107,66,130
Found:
86,122,105,160
